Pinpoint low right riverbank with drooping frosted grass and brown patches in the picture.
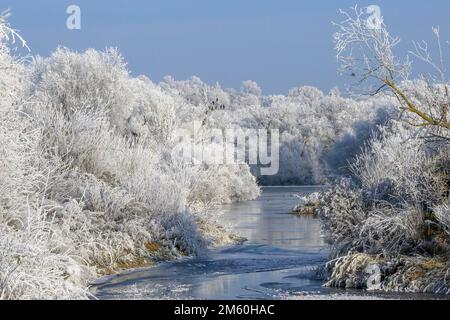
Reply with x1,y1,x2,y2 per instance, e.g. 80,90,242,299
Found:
296,175,450,295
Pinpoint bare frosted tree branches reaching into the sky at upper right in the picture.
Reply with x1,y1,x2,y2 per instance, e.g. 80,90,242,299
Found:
334,7,450,129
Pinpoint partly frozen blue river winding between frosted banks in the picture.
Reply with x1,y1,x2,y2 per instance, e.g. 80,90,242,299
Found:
92,187,446,300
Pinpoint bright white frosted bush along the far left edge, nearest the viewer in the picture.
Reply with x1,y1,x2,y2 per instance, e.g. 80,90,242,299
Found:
0,16,89,299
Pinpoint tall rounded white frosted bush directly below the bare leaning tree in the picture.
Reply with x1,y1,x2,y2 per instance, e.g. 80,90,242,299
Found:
351,123,447,206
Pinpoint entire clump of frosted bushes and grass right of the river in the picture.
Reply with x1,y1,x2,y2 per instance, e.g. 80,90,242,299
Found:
312,122,450,293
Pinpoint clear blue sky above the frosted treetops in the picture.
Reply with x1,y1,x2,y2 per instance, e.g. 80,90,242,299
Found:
0,0,450,93
